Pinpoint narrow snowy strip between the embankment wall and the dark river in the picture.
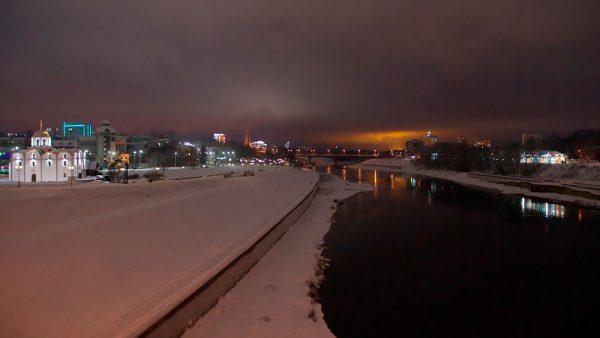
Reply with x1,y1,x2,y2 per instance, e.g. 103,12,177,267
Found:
184,176,373,338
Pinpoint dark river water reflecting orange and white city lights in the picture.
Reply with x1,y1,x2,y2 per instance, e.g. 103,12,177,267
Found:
319,167,600,338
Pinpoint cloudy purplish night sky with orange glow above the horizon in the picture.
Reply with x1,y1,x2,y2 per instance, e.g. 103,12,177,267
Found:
0,0,600,146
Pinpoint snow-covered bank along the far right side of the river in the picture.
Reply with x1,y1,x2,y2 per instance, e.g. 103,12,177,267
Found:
350,159,600,208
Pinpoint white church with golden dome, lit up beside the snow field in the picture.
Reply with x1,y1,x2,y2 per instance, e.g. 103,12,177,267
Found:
8,121,84,182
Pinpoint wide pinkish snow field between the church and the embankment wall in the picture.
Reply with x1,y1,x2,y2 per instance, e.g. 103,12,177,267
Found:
0,168,318,337
